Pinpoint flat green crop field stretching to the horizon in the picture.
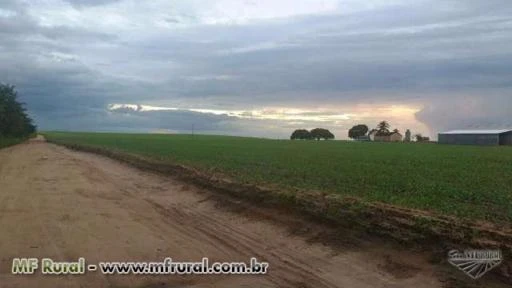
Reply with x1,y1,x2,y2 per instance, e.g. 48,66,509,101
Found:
44,132,512,223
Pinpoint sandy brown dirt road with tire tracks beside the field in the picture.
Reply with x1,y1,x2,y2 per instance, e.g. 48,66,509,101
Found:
0,141,441,288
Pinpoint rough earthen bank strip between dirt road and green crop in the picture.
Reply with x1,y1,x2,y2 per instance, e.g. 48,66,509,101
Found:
47,139,512,284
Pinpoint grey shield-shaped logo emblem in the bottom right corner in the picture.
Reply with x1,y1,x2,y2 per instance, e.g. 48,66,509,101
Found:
448,250,503,280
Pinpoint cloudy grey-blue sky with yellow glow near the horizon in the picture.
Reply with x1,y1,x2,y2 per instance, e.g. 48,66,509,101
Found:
0,0,512,139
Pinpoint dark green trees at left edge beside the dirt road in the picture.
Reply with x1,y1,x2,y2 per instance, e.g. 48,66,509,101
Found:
0,84,36,138
